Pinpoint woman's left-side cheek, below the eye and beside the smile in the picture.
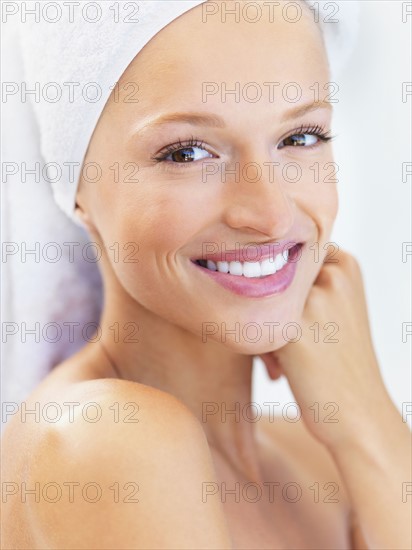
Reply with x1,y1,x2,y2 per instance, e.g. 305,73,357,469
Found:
98,181,209,298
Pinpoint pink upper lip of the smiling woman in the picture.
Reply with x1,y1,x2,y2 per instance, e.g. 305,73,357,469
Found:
193,240,299,262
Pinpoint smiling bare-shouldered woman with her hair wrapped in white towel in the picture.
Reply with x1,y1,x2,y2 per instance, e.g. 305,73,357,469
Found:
2,1,411,550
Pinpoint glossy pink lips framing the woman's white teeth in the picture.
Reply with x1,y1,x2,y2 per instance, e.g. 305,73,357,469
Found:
191,242,304,298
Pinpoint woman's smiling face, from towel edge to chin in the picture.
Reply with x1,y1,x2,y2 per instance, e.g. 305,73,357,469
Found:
77,3,337,354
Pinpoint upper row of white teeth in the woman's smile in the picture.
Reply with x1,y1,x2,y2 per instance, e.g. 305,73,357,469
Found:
201,250,289,279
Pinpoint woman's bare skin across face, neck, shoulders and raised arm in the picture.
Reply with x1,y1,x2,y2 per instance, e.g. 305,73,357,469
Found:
3,1,411,549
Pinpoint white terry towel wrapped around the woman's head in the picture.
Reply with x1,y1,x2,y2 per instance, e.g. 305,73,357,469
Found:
2,0,358,422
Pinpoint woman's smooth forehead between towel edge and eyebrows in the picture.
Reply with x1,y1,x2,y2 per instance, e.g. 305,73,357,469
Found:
112,1,329,123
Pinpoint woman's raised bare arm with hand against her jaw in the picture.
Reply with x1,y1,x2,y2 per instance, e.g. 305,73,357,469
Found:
262,251,412,550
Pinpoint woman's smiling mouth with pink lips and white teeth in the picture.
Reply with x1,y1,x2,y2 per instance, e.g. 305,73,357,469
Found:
192,243,303,298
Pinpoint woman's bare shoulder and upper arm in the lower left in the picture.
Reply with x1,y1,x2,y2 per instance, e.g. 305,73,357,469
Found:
3,379,230,549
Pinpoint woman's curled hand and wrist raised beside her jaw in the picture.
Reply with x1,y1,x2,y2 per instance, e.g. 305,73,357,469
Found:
261,251,393,447
